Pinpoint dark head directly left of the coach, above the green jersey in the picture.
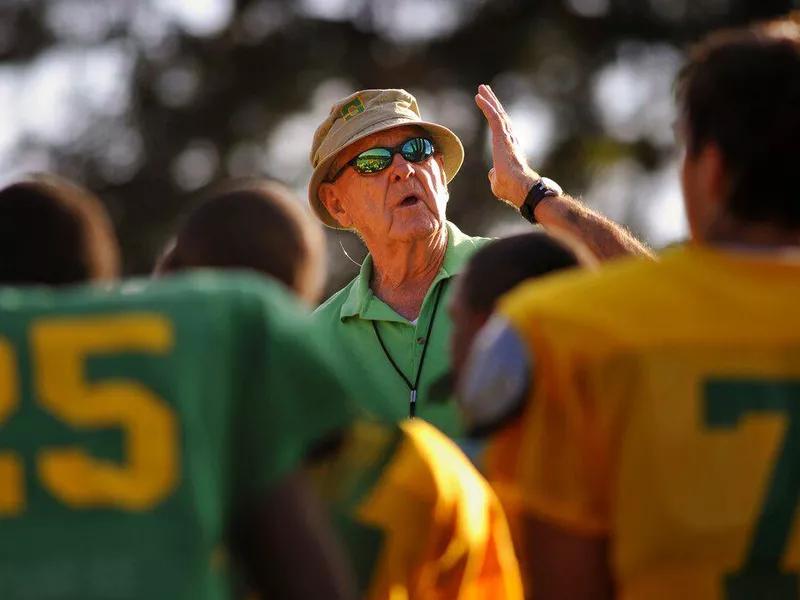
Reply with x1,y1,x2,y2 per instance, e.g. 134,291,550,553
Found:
156,180,324,302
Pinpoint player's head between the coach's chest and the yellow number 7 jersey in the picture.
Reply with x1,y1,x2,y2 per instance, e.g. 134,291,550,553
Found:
448,232,584,381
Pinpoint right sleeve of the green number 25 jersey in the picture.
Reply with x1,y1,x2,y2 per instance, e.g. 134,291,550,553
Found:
233,288,352,503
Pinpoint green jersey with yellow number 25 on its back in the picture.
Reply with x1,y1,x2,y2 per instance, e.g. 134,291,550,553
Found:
0,274,349,600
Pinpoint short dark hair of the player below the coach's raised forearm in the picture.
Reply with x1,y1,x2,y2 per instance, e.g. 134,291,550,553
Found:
461,232,581,312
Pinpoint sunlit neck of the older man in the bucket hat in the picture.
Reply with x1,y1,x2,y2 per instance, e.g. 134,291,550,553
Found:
367,226,447,321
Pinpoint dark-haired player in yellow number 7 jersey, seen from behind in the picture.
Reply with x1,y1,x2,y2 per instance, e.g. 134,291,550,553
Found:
460,16,800,600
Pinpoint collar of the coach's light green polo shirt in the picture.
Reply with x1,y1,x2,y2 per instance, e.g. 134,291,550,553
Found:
339,221,475,323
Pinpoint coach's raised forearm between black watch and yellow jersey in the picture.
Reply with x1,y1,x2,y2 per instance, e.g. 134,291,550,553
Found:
534,195,654,261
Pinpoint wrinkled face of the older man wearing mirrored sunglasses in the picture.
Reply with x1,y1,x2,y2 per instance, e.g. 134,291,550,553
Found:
319,126,448,245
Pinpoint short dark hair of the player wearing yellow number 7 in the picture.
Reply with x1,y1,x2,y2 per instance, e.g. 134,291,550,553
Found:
676,12,800,230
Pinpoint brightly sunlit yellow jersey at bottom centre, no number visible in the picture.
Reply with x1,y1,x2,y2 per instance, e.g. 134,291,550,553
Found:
314,419,522,600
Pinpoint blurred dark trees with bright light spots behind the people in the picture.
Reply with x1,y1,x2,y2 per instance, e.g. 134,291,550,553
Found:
0,0,800,293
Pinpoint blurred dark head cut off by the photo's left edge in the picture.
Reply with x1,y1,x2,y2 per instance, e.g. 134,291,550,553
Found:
0,174,120,286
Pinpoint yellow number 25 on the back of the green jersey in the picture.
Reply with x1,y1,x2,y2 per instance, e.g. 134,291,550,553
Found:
0,314,179,518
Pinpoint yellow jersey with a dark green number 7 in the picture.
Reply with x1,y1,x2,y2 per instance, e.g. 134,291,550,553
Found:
485,246,800,600
